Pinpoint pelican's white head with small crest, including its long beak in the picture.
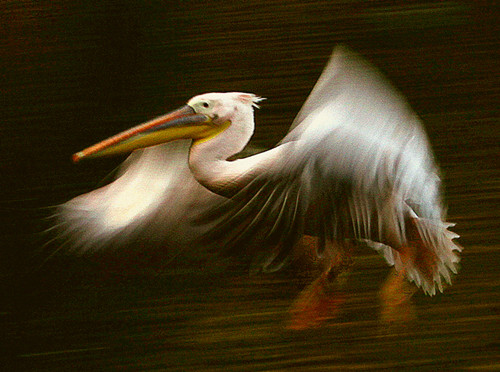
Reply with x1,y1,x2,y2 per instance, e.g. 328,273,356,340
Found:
73,92,262,162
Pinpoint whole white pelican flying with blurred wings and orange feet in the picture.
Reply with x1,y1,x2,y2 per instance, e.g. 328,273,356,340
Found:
55,46,460,328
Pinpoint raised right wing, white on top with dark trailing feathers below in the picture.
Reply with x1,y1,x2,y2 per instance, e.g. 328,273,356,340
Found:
201,47,458,292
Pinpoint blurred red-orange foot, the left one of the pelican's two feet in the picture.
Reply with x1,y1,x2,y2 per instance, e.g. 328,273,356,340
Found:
287,274,345,330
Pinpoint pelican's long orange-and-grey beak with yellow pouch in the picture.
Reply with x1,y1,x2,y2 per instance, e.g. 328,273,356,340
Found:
73,105,214,163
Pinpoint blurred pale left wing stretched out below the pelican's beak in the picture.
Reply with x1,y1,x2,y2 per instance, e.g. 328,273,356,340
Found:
58,141,223,253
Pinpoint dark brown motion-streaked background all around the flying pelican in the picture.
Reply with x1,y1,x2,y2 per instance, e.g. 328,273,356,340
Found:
0,0,500,371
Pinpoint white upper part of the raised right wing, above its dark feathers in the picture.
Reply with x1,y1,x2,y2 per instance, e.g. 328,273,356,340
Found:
281,46,442,219
